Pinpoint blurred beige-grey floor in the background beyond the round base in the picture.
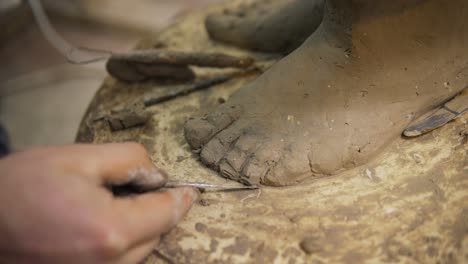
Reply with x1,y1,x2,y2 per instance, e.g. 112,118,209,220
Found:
0,0,219,151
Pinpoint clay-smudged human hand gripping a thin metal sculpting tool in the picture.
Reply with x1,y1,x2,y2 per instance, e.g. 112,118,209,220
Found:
0,143,198,264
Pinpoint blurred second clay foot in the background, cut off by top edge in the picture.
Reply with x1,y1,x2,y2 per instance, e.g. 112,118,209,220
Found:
205,0,323,53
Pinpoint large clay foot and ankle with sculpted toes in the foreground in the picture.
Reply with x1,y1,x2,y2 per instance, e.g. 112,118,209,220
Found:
185,0,468,186
